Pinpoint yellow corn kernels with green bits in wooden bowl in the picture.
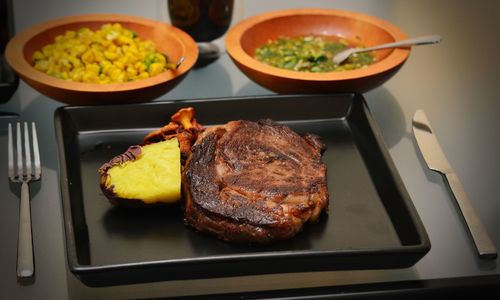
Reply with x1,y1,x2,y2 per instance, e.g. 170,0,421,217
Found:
32,23,175,84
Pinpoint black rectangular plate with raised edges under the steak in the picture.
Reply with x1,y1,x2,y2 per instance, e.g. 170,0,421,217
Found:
55,94,430,286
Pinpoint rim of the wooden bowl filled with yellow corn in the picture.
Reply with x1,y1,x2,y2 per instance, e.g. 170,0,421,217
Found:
5,14,198,92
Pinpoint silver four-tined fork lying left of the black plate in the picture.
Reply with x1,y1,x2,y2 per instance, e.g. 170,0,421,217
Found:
8,122,42,278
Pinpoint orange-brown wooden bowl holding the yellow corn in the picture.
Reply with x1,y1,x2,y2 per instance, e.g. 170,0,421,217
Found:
5,14,198,105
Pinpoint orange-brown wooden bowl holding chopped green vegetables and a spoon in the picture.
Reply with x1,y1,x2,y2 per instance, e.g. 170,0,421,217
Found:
226,9,410,94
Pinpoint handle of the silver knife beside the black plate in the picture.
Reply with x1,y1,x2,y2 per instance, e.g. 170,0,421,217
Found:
445,173,497,259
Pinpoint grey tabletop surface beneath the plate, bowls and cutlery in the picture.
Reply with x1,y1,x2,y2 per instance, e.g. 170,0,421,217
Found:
0,0,500,299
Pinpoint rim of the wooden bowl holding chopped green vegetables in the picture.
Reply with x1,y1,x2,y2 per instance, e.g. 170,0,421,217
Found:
226,8,411,81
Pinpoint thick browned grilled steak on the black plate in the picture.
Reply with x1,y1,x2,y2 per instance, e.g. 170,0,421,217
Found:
183,120,328,243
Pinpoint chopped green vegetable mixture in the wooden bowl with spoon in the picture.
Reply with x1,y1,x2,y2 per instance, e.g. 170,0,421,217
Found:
255,35,375,72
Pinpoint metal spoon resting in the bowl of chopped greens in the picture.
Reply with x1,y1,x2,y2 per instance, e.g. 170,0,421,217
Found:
333,35,441,65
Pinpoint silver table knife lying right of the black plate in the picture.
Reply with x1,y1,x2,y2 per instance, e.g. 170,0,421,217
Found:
412,110,497,259
